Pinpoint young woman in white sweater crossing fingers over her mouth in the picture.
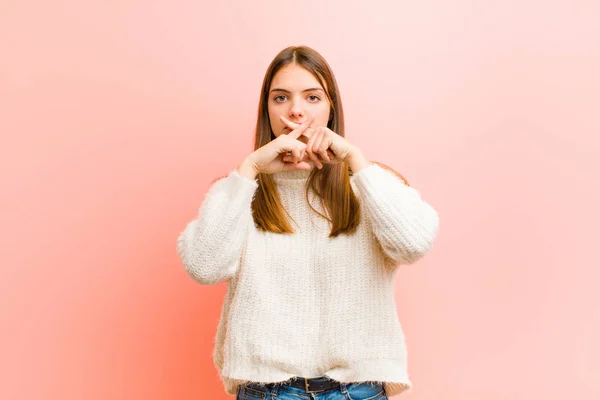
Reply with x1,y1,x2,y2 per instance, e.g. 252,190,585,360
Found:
177,46,438,400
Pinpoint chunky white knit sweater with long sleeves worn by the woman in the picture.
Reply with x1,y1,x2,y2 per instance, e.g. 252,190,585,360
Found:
177,164,438,396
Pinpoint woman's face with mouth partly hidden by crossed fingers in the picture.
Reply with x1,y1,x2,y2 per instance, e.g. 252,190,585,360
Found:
268,64,331,136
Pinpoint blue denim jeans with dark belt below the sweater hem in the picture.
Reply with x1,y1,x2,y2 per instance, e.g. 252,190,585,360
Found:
236,382,388,400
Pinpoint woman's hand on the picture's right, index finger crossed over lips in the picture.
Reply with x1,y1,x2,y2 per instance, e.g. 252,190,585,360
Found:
280,116,353,169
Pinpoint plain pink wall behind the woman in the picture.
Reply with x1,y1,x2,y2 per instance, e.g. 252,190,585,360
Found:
0,0,600,400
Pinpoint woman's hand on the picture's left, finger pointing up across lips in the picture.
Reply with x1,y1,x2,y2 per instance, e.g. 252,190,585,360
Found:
238,118,314,179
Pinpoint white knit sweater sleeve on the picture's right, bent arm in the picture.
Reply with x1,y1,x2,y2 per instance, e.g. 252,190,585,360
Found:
354,164,439,264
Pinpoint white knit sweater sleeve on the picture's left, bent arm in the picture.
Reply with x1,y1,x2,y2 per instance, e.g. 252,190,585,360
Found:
177,170,258,284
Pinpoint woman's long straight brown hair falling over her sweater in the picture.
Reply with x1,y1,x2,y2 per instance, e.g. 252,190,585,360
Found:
252,46,408,237
